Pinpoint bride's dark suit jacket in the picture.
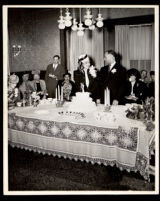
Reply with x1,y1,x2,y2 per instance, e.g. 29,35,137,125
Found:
73,69,100,101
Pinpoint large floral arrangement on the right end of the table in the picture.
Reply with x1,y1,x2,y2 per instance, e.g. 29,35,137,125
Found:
126,97,155,131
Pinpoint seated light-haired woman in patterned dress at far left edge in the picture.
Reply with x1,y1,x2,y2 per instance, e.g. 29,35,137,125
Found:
8,74,20,109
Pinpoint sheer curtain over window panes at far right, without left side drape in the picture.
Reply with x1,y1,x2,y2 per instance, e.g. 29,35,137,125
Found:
129,25,154,71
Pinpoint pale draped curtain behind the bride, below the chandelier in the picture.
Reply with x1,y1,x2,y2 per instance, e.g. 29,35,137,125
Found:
66,29,104,79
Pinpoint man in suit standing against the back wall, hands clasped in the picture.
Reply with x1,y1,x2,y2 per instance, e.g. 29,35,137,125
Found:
45,55,65,98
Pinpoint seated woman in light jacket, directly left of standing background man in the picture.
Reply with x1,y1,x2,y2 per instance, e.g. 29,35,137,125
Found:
28,70,47,98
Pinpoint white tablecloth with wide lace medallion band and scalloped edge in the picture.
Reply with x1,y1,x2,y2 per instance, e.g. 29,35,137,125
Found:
8,104,154,180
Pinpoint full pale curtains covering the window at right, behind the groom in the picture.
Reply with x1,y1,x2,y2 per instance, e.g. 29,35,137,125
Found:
115,24,154,71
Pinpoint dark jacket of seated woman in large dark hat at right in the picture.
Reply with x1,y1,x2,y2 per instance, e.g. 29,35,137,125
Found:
125,80,147,104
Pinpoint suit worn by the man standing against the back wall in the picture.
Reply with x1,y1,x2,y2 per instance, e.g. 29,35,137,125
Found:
45,64,65,98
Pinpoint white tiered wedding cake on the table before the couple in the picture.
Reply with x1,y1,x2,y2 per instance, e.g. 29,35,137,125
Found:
68,92,96,112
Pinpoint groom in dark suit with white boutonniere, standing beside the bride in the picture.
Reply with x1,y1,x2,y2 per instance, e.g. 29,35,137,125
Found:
98,50,126,105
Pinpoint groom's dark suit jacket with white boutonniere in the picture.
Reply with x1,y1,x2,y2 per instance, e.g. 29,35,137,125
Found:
98,63,126,104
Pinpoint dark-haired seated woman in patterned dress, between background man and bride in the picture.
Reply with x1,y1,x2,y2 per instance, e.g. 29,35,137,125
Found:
58,73,76,101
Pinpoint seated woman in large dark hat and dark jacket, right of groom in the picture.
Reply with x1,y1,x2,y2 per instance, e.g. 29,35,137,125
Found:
124,68,147,104
